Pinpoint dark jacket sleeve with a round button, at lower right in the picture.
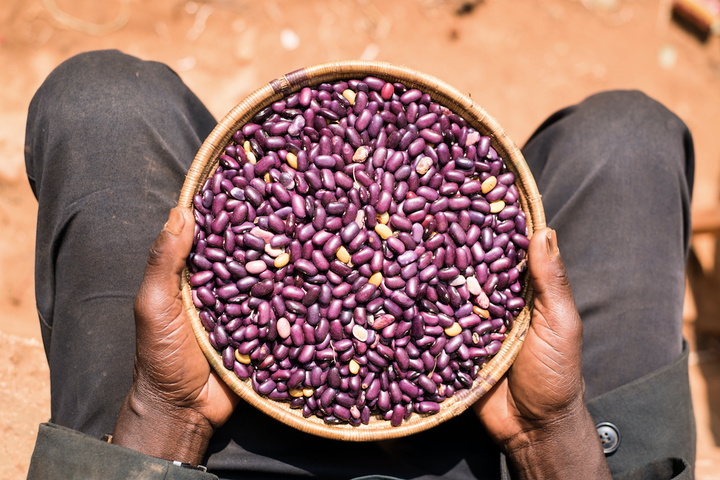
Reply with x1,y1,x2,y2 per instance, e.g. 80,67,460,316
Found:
587,341,696,480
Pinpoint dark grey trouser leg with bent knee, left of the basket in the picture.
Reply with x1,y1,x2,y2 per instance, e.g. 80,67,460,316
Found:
25,51,215,436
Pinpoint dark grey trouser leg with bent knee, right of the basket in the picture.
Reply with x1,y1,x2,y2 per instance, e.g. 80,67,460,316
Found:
523,91,694,399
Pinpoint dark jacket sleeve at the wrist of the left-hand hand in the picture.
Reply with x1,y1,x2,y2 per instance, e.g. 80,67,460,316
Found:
28,423,217,480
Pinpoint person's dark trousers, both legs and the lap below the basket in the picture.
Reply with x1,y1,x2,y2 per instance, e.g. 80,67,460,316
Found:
25,51,694,478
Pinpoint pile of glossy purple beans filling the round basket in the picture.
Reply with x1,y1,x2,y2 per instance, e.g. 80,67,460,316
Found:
188,77,529,426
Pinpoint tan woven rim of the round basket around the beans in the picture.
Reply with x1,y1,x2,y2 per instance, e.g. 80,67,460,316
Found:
178,61,545,441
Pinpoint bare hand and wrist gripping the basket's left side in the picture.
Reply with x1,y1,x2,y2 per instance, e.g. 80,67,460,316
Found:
113,207,238,464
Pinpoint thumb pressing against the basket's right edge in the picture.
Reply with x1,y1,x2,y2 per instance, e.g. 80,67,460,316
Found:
528,228,582,350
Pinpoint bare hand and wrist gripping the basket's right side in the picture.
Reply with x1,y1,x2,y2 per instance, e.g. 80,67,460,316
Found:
474,229,611,479
